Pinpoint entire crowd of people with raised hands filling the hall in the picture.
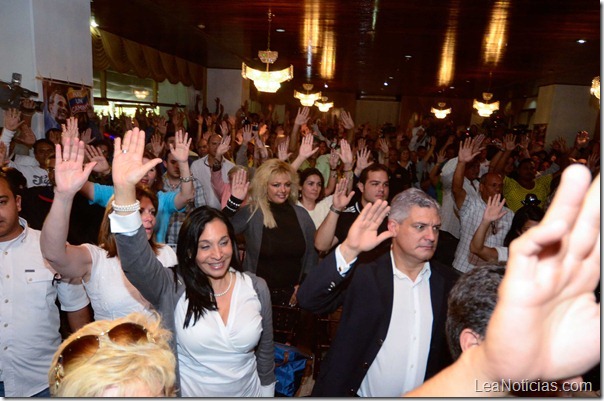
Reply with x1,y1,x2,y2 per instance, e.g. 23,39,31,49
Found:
0,99,600,397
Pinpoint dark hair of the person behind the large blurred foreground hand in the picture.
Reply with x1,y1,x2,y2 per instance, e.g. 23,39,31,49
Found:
445,266,505,360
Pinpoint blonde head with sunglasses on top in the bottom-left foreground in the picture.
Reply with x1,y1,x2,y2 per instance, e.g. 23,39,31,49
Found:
48,313,176,398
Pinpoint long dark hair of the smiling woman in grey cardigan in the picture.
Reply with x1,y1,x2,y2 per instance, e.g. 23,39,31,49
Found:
176,206,242,328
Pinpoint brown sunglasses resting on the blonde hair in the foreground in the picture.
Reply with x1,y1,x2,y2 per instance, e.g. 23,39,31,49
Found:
55,322,155,388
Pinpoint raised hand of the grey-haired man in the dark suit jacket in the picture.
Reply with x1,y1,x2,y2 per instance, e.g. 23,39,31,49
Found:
340,199,394,262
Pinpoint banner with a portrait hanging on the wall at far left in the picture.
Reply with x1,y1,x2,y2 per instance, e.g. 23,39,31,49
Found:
42,78,92,132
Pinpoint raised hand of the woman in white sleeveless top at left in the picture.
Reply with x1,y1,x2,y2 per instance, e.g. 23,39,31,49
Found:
55,136,96,197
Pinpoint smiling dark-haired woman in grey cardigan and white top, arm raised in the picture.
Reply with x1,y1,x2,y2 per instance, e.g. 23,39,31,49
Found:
110,129,275,397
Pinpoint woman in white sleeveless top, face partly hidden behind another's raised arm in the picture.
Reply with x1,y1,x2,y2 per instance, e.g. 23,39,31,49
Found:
40,140,176,320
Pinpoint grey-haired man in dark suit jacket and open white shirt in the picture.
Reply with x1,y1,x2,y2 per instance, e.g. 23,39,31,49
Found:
298,188,458,397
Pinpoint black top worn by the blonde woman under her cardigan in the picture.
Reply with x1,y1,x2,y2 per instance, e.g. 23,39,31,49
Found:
256,202,306,290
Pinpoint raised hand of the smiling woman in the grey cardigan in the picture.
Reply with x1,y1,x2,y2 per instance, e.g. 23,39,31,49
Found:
111,128,161,191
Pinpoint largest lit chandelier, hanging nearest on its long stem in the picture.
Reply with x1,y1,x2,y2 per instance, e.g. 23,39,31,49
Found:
241,8,294,93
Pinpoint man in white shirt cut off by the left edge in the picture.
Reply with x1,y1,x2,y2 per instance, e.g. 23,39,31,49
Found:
0,174,91,397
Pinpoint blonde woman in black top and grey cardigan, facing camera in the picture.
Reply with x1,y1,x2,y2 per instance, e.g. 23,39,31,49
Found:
223,159,318,306
